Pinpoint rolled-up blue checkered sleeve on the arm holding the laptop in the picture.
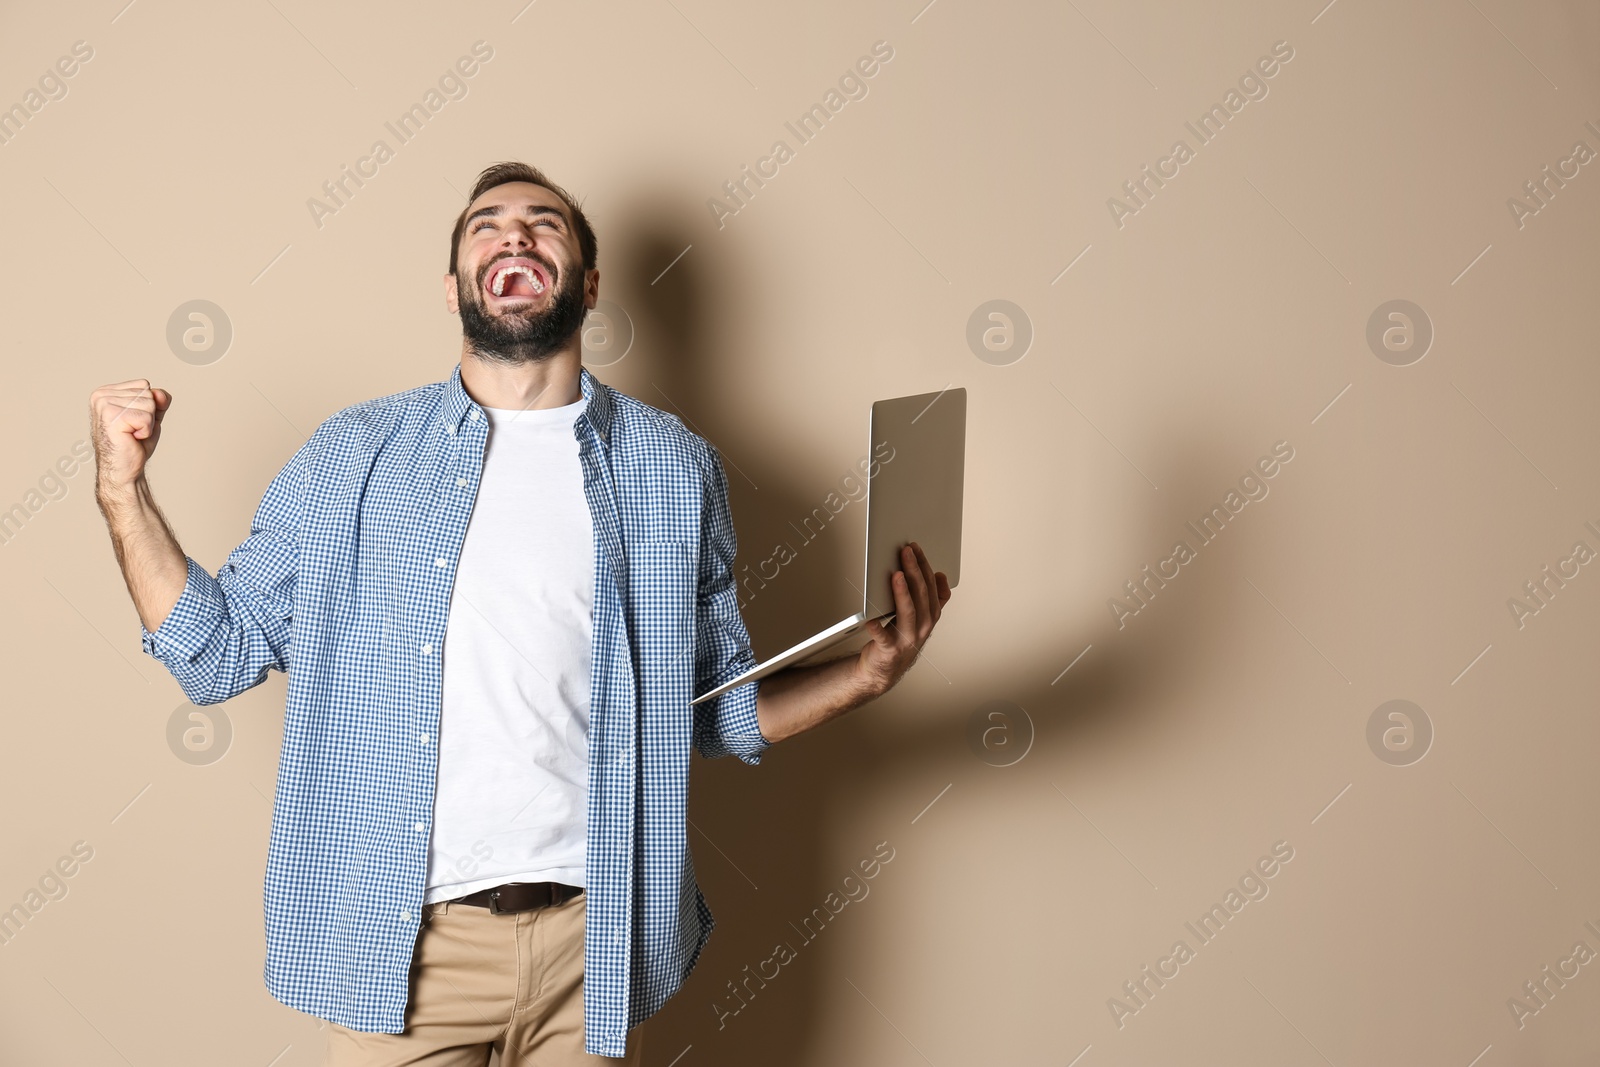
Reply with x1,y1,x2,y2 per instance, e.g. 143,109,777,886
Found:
693,445,771,765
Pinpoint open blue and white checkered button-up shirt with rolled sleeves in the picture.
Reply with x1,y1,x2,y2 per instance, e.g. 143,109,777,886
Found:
139,365,768,1056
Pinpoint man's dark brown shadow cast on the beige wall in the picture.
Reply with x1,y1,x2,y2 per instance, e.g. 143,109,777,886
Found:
566,200,1262,1067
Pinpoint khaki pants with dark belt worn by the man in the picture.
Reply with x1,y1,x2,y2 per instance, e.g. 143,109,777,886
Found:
325,893,643,1067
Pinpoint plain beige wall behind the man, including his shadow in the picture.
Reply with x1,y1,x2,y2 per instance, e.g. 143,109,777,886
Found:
0,0,1600,1067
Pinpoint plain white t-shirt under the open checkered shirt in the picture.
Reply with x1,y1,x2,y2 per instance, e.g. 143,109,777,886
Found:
422,400,594,904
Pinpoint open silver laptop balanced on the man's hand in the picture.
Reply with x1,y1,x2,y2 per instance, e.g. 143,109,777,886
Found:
690,389,966,704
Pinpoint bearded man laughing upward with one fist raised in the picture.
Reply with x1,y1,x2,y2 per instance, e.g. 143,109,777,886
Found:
91,163,950,1067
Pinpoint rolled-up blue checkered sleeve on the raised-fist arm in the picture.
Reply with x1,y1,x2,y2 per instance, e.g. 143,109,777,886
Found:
139,437,315,704
